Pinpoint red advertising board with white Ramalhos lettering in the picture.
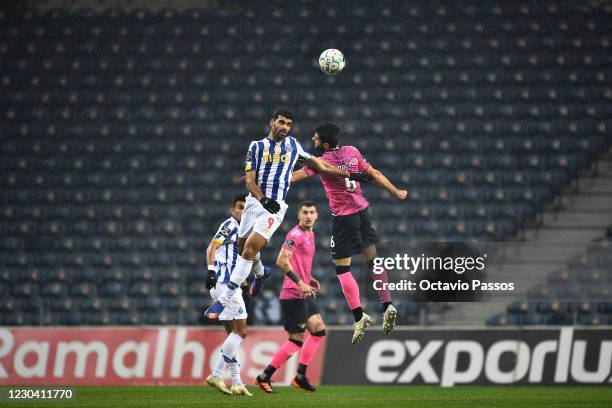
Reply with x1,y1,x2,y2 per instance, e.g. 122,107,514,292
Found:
0,326,325,385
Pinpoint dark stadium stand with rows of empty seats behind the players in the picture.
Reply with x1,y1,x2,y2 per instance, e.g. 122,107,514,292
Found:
0,0,612,325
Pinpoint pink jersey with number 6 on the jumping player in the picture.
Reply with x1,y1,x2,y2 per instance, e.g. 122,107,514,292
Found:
302,146,370,215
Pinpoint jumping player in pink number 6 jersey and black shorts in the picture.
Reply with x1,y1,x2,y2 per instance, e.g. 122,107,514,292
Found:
291,123,408,343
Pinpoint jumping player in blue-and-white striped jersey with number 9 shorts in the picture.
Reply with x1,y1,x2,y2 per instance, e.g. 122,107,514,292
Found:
204,108,366,319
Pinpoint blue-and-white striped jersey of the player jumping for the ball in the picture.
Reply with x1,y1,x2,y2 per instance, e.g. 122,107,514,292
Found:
245,136,312,201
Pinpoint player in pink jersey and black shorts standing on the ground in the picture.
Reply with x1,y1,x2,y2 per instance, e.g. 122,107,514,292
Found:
254,201,325,393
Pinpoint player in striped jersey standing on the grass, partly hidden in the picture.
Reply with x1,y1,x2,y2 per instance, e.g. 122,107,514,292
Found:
206,194,252,396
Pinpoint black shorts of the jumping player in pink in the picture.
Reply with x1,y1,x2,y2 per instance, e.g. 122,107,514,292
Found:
330,208,379,259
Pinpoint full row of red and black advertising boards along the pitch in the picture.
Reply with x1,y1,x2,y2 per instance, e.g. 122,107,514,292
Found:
0,326,612,386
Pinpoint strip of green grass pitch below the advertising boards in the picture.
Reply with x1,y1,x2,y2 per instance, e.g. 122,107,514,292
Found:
5,386,612,408
